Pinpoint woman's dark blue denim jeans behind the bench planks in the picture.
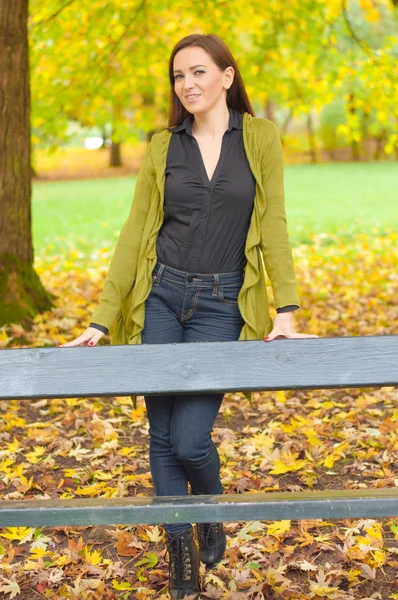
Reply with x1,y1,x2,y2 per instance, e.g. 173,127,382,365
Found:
142,262,244,533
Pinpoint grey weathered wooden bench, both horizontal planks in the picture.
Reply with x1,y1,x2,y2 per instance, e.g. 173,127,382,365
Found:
0,335,398,527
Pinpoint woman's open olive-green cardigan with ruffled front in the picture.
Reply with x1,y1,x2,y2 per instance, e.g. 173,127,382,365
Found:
91,112,300,400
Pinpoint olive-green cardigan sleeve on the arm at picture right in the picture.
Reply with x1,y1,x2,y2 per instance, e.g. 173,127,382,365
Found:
260,119,300,309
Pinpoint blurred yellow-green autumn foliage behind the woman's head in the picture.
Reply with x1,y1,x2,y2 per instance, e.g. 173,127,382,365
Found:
30,0,398,162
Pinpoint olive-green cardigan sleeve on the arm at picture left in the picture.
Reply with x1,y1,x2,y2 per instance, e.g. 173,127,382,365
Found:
91,143,156,329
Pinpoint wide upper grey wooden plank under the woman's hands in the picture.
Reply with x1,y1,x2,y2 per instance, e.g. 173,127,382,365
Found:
0,335,398,399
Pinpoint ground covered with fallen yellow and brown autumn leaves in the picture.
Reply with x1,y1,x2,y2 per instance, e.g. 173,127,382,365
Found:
0,233,398,600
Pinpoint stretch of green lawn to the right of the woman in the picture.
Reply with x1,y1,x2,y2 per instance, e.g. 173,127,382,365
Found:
285,162,398,245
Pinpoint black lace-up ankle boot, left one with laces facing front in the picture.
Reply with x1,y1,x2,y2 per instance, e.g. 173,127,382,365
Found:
166,528,199,600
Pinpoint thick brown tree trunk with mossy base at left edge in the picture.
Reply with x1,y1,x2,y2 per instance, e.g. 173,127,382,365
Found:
0,0,52,326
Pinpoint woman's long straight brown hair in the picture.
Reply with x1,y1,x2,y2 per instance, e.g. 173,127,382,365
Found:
168,33,255,127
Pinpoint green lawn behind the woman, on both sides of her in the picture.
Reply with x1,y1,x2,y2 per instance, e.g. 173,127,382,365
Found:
33,162,398,257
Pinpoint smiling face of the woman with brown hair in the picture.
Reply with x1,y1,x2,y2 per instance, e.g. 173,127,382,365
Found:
173,46,234,114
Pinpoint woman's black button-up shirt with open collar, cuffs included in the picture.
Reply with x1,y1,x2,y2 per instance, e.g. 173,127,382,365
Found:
90,108,298,333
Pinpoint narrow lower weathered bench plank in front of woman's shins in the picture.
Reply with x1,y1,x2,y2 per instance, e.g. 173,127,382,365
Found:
0,488,398,527
